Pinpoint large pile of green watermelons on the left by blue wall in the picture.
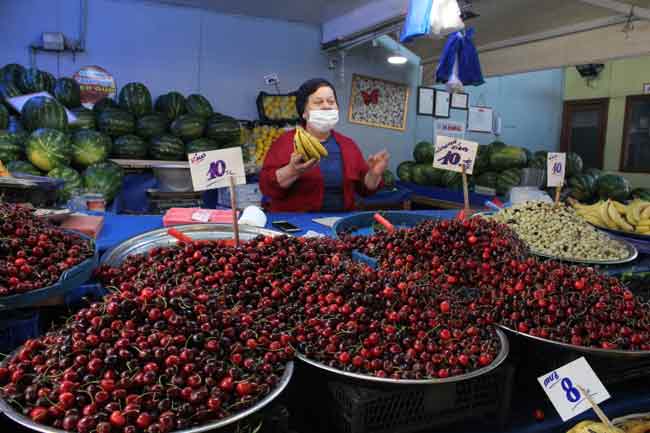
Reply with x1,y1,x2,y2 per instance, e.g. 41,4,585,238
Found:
0,64,246,201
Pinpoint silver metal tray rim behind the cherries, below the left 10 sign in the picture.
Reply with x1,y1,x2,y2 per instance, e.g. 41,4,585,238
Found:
100,224,284,266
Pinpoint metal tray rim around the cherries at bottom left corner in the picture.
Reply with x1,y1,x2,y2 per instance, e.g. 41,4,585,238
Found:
0,360,293,433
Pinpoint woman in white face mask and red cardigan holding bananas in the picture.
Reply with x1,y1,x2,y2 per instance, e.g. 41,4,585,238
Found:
260,79,389,212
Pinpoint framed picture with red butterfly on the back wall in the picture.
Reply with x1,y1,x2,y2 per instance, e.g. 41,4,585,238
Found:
348,74,409,131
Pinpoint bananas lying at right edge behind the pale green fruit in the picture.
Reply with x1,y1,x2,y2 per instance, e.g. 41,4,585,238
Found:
570,200,650,235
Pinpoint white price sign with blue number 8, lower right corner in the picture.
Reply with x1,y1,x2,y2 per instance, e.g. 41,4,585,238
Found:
537,357,610,421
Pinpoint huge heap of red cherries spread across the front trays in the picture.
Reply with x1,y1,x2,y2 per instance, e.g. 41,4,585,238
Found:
0,218,650,433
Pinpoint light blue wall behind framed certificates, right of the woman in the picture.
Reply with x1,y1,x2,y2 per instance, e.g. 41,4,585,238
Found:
417,69,564,151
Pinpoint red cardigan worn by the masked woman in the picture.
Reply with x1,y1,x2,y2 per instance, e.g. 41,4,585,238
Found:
260,130,381,212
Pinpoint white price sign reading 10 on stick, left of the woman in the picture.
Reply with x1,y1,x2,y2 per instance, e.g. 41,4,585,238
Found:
187,147,246,191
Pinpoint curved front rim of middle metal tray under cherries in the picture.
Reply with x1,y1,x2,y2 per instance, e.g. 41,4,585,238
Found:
296,328,510,385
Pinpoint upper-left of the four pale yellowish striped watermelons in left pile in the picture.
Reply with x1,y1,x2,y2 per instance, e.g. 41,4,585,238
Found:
25,128,72,172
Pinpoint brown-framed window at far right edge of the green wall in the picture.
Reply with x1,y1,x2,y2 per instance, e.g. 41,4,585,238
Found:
620,95,650,173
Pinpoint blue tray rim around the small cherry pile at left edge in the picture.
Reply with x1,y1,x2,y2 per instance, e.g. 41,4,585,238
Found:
0,230,99,311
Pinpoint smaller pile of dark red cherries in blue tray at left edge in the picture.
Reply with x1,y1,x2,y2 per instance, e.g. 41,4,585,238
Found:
0,203,94,296
